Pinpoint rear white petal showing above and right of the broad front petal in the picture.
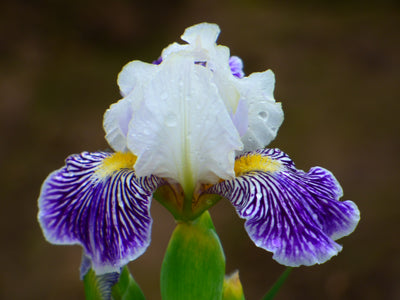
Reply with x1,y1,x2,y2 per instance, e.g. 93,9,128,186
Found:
162,23,283,151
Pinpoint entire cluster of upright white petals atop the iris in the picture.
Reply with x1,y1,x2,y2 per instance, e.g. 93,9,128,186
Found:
104,23,283,186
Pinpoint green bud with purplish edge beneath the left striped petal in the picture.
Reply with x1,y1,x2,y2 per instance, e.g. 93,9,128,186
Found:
83,269,119,300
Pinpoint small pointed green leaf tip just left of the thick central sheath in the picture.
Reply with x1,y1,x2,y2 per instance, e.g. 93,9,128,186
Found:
112,266,145,300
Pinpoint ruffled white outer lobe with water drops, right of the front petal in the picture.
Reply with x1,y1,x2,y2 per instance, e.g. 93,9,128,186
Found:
237,70,283,151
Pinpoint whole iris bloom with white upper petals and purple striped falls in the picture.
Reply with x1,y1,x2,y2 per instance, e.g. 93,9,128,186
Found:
38,23,359,274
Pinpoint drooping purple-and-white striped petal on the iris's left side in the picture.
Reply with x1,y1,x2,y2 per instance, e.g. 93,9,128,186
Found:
38,152,160,275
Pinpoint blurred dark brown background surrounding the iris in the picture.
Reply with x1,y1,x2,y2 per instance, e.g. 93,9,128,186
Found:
0,0,400,300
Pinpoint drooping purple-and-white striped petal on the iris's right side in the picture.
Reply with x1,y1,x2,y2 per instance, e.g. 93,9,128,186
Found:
208,149,360,266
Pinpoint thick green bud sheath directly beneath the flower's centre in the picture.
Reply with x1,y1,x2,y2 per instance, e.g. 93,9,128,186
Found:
161,211,225,300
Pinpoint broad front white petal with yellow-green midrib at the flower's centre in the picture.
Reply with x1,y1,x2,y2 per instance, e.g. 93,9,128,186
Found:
128,54,242,189
